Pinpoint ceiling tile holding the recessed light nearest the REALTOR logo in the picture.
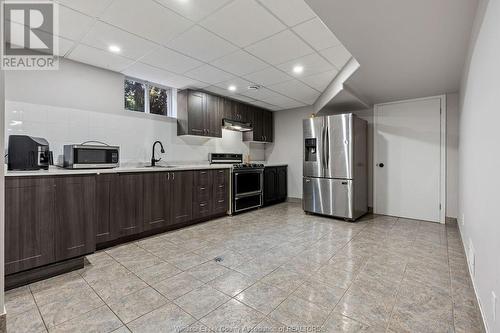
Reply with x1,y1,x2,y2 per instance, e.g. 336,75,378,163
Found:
82,22,157,59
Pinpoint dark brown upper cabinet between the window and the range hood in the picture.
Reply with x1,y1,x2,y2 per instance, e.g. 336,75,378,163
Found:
177,89,223,138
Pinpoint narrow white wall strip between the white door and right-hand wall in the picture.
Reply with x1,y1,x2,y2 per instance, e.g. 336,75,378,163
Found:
446,93,459,218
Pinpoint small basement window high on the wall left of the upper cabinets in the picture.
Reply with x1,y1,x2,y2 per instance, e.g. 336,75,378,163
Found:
124,77,176,118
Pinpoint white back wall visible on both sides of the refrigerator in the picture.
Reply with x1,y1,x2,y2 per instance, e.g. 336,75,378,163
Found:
266,106,373,202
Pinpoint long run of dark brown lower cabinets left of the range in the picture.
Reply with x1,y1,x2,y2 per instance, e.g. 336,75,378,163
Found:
5,170,229,274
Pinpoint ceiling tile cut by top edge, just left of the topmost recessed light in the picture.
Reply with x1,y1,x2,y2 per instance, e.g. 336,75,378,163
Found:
102,0,192,44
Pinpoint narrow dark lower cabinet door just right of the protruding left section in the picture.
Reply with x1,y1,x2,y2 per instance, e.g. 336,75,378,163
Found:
96,175,119,243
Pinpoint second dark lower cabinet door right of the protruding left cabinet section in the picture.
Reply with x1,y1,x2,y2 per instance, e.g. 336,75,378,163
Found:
111,173,144,237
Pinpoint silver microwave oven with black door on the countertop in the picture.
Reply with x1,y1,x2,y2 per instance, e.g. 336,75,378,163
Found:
63,145,120,169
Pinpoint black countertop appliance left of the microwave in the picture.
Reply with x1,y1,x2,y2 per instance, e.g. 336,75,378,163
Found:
7,135,53,170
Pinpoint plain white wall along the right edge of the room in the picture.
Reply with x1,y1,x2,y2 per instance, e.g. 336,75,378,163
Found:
459,0,500,332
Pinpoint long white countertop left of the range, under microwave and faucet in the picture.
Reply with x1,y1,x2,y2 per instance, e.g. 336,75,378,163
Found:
5,164,231,177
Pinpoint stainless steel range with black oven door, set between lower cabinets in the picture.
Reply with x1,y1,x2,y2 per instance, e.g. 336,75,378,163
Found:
209,154,264,214
